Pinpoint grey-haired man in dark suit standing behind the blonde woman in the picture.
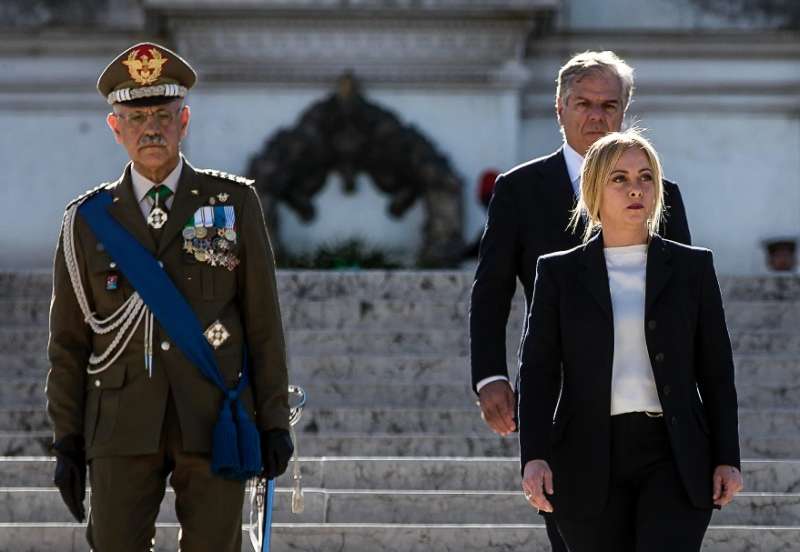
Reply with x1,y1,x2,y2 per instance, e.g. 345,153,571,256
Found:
469,51,691,552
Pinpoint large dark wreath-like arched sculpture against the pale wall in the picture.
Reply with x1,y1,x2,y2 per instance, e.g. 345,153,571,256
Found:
247,74,464,267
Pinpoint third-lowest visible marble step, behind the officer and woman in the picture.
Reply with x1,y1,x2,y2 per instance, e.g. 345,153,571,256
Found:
0,456,800,493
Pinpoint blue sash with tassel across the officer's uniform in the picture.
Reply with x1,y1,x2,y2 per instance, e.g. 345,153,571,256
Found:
78,191,262,480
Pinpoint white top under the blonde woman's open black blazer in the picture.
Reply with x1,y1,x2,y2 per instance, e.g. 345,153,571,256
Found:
604,245,662,416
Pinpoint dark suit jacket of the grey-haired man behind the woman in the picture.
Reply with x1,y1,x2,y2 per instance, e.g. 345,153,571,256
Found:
469,149,691,389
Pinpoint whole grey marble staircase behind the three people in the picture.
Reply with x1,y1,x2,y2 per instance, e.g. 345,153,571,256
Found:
0,272,800,552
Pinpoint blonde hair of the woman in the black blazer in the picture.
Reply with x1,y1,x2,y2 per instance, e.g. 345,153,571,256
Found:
569,129,664,243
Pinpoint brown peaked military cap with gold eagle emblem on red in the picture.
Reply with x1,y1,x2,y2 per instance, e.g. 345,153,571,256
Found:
97,42,197,104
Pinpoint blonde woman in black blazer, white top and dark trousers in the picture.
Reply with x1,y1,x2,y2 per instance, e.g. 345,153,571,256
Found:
519,131,742,552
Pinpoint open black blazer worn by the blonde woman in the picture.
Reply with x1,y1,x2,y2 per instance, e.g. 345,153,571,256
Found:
519,234,739,518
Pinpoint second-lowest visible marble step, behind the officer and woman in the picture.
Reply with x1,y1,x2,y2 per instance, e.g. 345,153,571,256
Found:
0,483,800,526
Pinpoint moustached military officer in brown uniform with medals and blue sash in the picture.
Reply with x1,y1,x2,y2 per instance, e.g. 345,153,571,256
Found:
47,44,293,552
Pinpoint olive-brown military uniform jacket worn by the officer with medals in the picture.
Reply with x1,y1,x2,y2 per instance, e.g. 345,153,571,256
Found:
47,160,289,458
